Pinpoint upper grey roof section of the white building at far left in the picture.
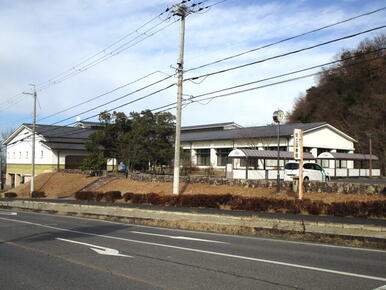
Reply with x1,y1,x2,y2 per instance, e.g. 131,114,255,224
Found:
23,124,96,139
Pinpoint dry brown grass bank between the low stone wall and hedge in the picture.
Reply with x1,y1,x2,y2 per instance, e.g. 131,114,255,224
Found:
98,179,386,203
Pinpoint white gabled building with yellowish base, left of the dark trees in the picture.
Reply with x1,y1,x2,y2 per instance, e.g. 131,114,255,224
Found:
3,122,102,187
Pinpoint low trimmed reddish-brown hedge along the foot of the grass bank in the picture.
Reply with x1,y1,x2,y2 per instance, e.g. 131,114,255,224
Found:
75,192,386,217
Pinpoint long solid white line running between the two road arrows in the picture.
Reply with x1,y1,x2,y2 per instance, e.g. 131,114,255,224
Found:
0,218,386,282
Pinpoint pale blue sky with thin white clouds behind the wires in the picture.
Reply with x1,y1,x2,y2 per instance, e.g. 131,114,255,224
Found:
0,0,386,131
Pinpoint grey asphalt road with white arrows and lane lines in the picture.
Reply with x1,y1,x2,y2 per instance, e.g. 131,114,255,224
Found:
0,210,386,289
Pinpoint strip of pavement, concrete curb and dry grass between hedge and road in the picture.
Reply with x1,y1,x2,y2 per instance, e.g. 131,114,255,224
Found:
0,199,386,244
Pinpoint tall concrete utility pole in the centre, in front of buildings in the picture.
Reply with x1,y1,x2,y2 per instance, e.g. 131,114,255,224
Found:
173,3,191,194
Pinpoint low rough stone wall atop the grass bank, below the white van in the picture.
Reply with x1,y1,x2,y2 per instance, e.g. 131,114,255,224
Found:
128,174,386,195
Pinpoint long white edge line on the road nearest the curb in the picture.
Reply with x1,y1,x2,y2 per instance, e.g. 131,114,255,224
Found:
12,212,386,253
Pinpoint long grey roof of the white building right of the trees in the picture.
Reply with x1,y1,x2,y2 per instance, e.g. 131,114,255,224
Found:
181,122,327,142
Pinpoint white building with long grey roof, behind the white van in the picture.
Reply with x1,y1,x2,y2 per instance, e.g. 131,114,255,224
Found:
181,122,380,179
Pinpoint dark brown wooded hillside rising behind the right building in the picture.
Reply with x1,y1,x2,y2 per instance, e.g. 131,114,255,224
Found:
289,33,386,173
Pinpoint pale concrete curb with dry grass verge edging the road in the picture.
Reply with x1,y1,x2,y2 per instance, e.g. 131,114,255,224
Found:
0,200,386,248
